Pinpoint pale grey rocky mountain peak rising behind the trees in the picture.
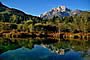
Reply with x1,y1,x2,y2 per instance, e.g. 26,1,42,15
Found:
40,6,81,19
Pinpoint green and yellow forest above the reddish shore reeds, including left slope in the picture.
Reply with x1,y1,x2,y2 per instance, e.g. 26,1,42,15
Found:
0,3,90,33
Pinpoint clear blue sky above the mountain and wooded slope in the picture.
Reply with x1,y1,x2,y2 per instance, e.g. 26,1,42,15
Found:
0,0,90,16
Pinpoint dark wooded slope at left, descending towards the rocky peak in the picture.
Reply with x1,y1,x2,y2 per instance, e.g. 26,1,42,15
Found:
0,2,41,24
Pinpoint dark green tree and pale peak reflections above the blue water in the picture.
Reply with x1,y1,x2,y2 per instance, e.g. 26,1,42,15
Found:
0,37,90,58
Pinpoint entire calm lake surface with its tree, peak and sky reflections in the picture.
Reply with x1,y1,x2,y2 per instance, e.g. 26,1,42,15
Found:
0,37,90,60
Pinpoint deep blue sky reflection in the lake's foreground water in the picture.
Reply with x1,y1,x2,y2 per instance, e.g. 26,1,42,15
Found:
0,45,83,60
